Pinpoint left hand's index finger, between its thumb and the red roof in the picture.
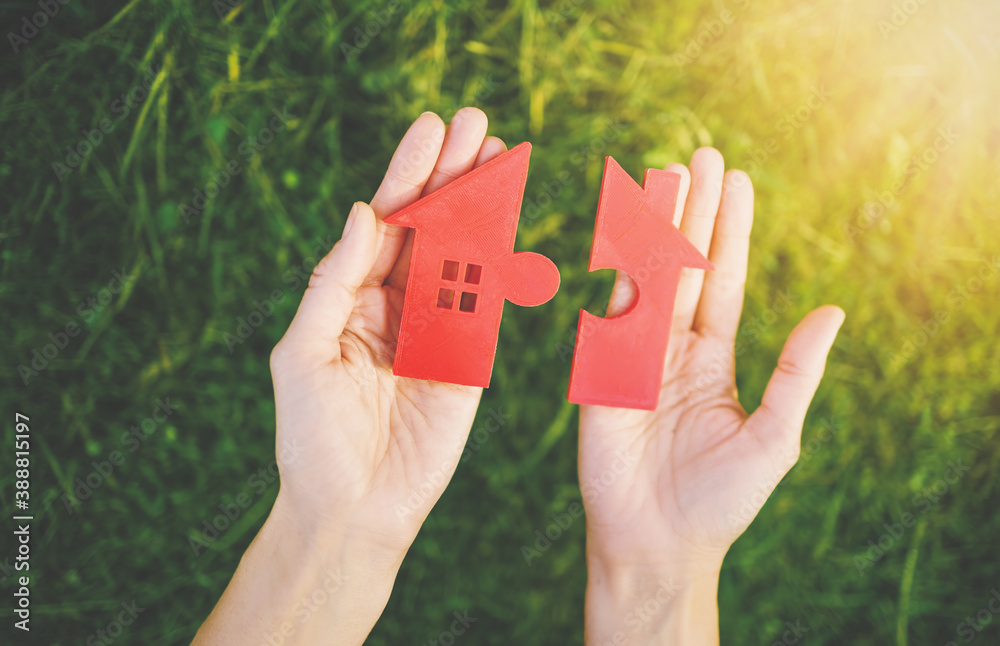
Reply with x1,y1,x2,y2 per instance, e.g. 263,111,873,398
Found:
365,112,445,285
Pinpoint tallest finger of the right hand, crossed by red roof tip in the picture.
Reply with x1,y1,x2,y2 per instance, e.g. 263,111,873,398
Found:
673,148,725,331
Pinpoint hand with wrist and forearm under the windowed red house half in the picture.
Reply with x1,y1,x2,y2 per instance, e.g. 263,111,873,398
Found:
195,108,506,645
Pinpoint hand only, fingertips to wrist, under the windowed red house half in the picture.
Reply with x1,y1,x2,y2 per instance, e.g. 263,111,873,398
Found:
271,108,506,551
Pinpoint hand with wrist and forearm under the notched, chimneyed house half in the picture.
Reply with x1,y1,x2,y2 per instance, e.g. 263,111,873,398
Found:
579,148,844,644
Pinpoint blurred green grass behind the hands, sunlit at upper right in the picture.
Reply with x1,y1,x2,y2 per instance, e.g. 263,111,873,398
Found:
0,0,1000,646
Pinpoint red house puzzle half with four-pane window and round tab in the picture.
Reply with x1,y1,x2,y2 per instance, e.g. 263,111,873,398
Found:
385,142,559,387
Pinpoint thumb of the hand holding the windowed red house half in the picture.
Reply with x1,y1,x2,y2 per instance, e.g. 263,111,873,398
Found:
278,202,377,363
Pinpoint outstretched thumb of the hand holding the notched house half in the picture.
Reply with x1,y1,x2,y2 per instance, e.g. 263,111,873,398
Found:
746,305,844,454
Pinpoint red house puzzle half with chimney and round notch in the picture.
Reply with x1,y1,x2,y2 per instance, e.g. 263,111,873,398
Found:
567,157,714,410
